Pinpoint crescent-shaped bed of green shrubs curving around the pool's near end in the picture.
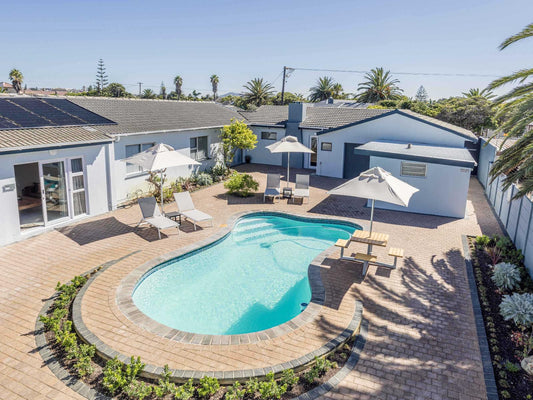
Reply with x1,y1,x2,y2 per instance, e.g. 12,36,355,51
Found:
40,269,355,400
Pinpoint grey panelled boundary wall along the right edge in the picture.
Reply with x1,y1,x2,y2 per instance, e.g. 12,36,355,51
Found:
478,139,533,276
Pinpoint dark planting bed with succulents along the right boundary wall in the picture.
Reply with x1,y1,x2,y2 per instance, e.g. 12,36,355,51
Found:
468,236,533,399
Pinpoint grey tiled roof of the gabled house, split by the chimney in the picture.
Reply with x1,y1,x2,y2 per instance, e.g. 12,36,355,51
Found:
239,105,477,141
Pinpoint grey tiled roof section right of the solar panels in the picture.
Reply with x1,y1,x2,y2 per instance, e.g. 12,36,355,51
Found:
67,96,242,135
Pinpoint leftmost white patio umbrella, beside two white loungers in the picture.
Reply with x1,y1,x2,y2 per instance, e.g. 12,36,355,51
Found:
122,143,200,208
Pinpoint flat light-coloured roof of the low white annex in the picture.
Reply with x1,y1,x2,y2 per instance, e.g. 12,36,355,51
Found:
354,141,476,168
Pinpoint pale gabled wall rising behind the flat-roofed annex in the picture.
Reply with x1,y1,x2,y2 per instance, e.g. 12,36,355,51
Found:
317,114,466,178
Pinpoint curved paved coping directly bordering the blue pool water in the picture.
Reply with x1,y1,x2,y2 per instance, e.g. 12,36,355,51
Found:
116,211,360,345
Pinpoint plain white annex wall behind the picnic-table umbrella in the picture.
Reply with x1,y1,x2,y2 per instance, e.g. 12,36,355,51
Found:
370,156,471,218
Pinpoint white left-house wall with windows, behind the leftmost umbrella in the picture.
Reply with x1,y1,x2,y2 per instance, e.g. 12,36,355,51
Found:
112,129,220,204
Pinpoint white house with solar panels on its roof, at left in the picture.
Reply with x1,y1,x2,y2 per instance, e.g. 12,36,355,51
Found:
0,97,242,245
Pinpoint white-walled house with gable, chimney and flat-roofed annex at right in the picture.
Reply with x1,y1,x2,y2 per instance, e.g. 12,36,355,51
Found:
241,103,478,218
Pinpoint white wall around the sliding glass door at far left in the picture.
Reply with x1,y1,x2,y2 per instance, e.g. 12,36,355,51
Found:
0,145,109,245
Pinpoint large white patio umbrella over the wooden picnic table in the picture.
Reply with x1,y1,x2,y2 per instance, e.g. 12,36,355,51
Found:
328,167,418,232
